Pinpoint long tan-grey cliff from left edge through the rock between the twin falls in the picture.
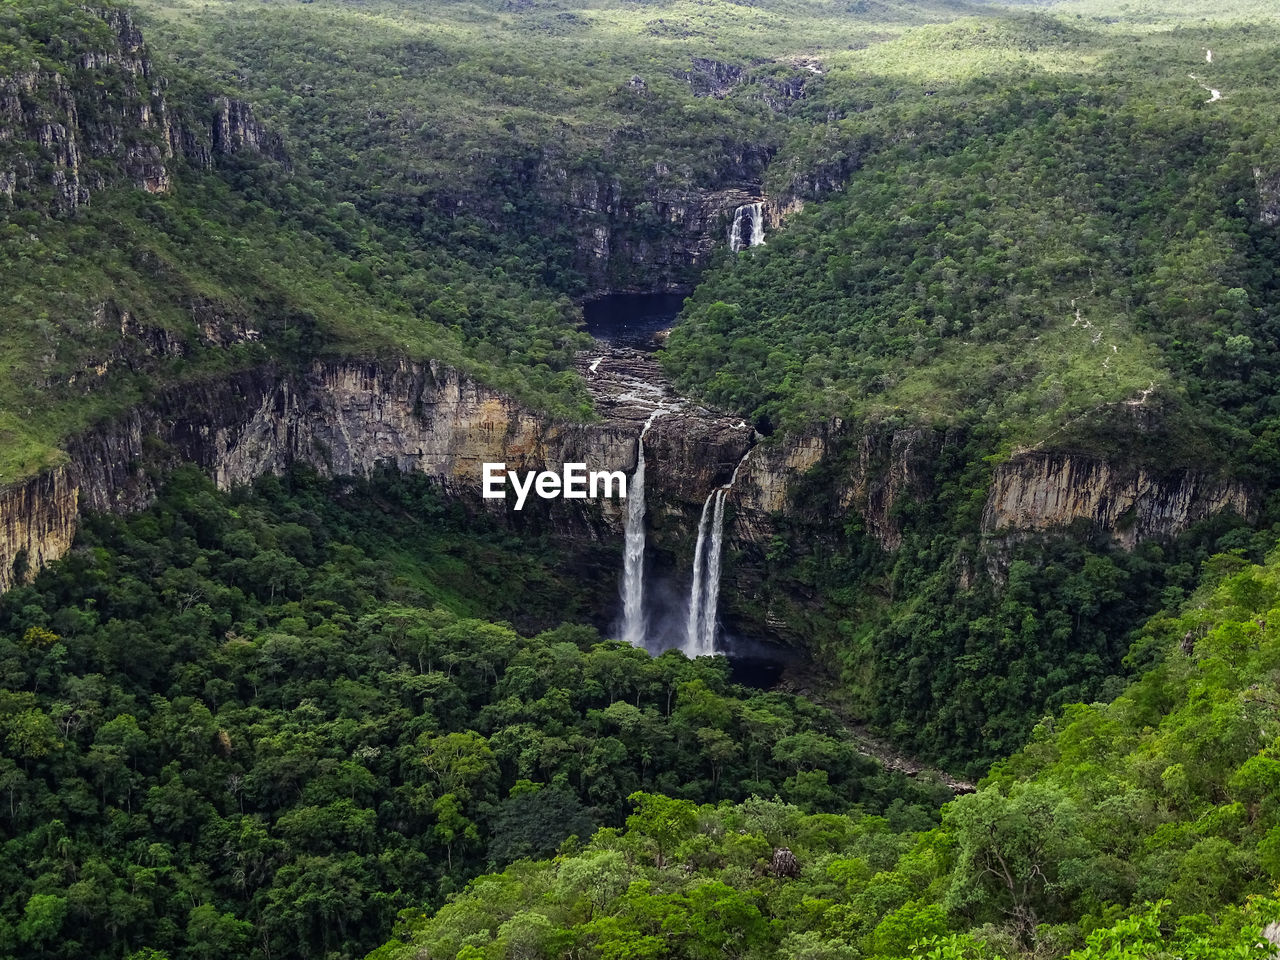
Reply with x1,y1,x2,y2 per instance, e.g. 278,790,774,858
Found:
0,358,753,589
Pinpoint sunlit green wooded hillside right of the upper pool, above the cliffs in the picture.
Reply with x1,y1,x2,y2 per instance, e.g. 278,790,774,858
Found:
667,54,1280,463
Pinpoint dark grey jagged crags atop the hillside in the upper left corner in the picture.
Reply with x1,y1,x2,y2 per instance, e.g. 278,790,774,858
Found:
0,8,287,214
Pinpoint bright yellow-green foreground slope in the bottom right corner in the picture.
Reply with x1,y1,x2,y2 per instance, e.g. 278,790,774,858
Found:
372,542,1280,960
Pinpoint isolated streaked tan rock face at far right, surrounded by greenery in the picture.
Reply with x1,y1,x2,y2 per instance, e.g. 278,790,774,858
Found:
982,453,1253,548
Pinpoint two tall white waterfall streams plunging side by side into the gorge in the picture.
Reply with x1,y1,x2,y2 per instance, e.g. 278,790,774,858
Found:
622,407,750,658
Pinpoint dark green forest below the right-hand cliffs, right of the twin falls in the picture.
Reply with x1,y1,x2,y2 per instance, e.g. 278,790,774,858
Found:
723,424,1280,777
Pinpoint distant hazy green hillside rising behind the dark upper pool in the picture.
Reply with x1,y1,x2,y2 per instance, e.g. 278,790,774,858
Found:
122,0,966,296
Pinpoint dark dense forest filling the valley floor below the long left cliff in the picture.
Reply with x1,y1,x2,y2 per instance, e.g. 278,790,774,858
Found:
0,472,945,960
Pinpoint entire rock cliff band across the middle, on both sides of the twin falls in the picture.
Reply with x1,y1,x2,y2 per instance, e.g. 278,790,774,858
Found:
0,349,1253,590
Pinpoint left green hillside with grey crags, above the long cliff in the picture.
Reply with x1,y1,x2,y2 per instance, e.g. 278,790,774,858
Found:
0,1,589,481
